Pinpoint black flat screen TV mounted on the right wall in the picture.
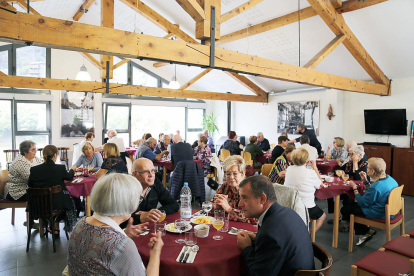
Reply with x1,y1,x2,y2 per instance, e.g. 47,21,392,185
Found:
364,109,407,135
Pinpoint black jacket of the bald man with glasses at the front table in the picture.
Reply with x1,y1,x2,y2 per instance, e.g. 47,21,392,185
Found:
121,178,180,228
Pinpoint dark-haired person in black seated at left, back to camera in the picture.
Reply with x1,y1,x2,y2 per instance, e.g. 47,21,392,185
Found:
28,145,77,237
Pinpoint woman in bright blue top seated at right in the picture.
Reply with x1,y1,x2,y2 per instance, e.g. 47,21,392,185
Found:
341,157,398,246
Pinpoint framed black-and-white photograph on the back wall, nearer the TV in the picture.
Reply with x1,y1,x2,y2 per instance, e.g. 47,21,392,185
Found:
277,101,319,135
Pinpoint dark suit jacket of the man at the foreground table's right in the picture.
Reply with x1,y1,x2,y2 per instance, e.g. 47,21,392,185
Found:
242,202,315,276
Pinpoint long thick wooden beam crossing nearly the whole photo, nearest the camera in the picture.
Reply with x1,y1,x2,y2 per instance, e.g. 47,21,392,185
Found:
0,10,388,95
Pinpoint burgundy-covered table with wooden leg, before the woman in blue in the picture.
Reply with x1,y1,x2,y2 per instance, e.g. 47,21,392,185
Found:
315,177,365,248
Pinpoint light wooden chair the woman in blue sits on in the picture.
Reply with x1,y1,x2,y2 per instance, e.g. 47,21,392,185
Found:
348,185,405,252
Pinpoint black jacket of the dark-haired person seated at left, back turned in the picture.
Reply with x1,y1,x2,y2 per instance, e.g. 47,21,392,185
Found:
28,159,75,210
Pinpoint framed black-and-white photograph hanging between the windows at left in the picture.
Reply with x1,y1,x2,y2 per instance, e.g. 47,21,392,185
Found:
60,91,95,137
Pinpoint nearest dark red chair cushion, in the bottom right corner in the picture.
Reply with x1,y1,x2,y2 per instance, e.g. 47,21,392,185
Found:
354,250,410,276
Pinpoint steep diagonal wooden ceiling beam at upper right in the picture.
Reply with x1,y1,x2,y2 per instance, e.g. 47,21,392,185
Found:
308,0,390,86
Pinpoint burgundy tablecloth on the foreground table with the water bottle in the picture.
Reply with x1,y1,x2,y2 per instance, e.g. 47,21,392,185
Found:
134,212,257,276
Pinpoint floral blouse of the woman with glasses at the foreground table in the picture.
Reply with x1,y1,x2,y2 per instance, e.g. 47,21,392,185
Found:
210,182,258,224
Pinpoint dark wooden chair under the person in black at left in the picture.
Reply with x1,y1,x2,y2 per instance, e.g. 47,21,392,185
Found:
26,185,69,253
